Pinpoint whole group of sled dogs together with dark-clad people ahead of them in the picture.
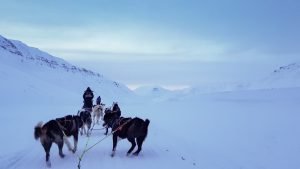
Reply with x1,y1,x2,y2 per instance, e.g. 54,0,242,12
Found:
34,87,150,167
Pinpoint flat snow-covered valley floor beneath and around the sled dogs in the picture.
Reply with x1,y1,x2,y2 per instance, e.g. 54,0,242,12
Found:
0,88,300,169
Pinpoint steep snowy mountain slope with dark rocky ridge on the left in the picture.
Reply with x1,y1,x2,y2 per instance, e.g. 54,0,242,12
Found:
0,36,133,104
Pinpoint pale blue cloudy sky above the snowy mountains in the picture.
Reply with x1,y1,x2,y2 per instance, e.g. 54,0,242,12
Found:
0,0,300,88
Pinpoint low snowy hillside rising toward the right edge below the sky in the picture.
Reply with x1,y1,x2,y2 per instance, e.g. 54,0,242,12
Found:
134,63,300,100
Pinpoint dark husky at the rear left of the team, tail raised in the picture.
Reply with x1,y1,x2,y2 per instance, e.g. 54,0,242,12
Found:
34,115,83,167
